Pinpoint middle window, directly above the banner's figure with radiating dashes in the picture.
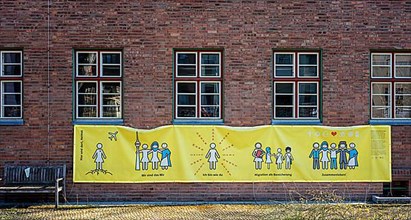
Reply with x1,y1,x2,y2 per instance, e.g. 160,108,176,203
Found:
174,51,222,119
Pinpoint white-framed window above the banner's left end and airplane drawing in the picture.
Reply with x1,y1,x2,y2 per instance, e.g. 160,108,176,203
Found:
75,51,122,119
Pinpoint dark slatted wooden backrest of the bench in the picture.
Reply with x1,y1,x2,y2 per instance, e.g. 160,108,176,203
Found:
3,165,66,185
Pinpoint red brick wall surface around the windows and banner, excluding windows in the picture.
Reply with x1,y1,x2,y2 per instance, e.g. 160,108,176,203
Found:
0,0,411,201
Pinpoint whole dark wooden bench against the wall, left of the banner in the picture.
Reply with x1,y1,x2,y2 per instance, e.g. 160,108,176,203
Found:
0,165,66,208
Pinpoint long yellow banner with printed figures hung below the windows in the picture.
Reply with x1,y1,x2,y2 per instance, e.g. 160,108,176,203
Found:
73,125,391,183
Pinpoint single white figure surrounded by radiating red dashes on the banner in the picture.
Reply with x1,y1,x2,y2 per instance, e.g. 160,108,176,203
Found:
190,128,237,176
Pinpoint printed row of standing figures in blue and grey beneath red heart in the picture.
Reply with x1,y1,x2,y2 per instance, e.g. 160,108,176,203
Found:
309,141,358,170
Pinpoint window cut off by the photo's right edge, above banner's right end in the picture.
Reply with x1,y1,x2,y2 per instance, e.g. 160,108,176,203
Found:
371,53,411,119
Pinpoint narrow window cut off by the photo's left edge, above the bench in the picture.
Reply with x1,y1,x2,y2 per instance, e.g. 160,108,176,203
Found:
0,51,23,119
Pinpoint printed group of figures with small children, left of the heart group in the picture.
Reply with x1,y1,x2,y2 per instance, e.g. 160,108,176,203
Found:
252,142,294,170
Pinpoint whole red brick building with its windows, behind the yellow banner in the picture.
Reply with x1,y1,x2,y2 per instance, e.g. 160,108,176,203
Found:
0,0,411,201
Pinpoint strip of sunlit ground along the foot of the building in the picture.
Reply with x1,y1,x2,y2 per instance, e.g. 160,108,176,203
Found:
0,204,411,220
